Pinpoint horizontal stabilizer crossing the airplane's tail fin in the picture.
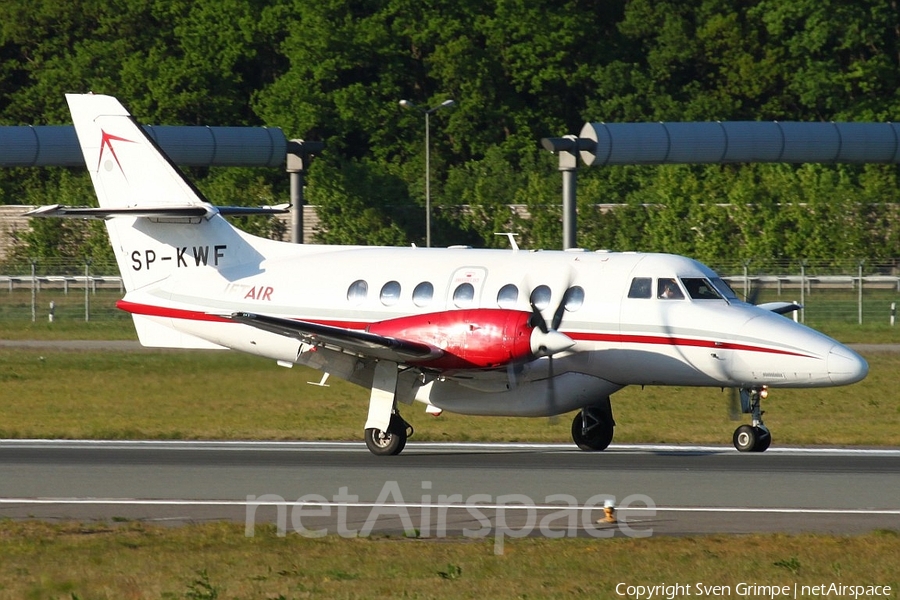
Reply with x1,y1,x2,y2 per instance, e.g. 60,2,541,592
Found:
23,204,290,219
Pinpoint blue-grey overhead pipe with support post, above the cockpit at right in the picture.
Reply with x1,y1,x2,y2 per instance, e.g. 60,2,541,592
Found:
541,121,900,248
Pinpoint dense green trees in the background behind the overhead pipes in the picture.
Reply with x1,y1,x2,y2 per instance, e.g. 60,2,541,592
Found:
0,0,900,262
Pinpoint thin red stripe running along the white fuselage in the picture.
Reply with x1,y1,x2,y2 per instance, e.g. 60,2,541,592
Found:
116,300,814,358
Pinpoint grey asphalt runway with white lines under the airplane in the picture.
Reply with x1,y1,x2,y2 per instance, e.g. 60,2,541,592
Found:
0,440,900,537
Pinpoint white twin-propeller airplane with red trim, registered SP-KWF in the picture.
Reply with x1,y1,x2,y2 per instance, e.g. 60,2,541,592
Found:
29,94,868,455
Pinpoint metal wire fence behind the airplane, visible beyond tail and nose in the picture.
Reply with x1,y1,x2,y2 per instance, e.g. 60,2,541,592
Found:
0,259,900,325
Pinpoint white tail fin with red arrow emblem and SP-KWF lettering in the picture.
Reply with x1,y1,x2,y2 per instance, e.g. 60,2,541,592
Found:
66,94,259,292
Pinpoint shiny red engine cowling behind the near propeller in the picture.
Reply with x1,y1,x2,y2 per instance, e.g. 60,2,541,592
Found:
366,308,534,369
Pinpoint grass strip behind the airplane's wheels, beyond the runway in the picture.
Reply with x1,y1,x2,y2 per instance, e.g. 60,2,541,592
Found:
0,349,900,446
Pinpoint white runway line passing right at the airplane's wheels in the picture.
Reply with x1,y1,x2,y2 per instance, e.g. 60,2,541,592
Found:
0,439,900,457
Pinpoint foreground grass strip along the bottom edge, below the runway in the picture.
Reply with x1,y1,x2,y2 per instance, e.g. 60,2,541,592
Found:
0,522,900,600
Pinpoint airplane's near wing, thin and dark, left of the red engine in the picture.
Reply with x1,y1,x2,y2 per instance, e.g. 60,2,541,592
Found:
229,312,443,363
